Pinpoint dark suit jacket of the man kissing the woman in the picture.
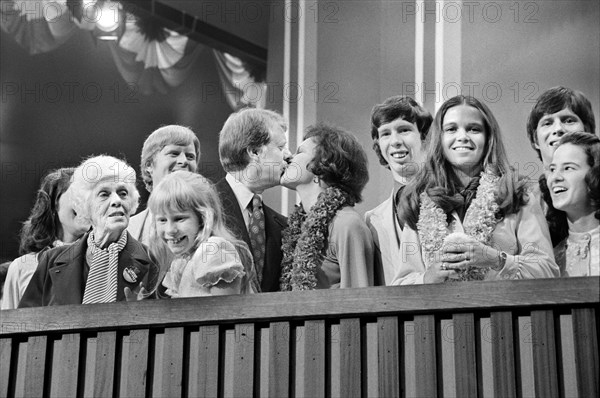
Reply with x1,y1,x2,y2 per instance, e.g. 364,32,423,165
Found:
216,178,287,292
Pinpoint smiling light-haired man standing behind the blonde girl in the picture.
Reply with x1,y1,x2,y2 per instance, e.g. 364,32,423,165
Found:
127,125,200,247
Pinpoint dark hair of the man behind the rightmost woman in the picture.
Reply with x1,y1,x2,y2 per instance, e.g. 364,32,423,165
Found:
527,86,596,160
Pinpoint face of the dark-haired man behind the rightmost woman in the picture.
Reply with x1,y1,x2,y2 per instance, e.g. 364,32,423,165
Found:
535,108,585,167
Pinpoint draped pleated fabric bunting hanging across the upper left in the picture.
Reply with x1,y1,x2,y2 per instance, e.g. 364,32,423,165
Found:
0,0,266,110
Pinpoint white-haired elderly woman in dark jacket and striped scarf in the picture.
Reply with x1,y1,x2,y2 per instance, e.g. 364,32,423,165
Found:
19,156,157,308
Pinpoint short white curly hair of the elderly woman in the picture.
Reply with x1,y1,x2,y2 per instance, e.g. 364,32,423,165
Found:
68,155,140,222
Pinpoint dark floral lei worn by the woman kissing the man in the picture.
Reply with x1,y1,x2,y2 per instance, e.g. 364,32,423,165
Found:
280,187,353,291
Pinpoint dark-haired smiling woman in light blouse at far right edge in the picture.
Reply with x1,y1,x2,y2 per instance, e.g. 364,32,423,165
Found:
546,132,600,276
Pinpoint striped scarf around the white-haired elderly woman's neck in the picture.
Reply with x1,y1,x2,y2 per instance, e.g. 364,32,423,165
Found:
82,231,127,304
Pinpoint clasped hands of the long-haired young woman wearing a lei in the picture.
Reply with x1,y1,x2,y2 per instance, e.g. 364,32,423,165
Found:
440,240,500,269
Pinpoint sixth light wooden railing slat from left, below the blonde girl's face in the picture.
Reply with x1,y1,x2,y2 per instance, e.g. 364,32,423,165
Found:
157,328,185,397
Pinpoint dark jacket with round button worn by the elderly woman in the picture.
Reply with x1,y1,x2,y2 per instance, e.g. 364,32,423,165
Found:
19,233,158,308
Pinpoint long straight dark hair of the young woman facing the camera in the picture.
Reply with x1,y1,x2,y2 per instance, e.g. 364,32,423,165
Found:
399,95,527,230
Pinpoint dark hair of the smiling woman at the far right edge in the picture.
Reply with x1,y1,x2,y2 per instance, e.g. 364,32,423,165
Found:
540,132,600,246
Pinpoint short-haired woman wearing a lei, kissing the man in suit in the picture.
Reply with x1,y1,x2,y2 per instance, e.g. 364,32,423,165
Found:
281,124,374,291
